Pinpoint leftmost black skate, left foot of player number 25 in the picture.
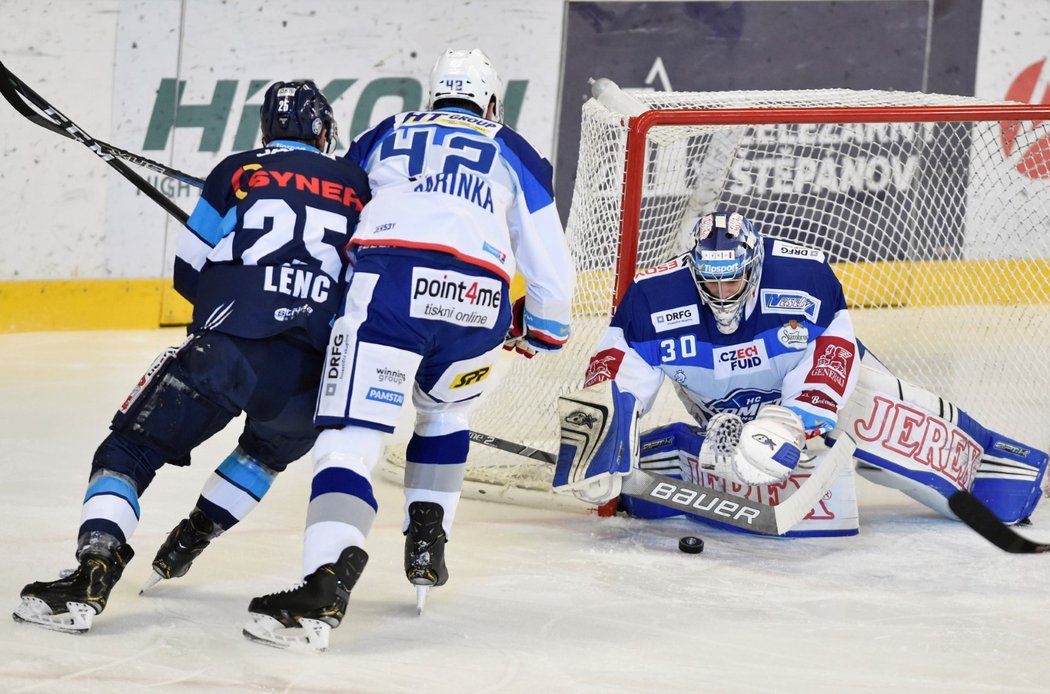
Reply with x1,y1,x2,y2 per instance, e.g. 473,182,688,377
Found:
12,544,134,633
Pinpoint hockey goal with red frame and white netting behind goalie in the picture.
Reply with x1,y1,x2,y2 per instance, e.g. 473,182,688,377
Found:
392,81,1050,504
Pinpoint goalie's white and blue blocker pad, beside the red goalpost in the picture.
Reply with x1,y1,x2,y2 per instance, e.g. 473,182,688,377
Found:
553,381,639,504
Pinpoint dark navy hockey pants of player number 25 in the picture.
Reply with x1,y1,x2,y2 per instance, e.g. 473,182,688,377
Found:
91,331,324,496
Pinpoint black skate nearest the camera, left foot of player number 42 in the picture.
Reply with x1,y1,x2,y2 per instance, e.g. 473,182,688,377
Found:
244,547,369,651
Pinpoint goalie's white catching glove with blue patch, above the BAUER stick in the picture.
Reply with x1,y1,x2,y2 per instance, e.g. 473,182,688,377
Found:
697,405,805,486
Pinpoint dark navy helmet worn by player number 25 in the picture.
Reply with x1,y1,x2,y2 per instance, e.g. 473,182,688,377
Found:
259,80,338,154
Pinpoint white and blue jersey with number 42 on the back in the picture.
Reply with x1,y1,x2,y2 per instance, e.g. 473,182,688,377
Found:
347,108,575,344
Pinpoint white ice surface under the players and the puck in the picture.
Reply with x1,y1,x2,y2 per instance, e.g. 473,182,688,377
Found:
0,330,1050,694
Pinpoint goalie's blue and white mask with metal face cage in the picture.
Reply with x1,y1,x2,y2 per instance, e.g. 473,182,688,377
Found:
690,211,764,335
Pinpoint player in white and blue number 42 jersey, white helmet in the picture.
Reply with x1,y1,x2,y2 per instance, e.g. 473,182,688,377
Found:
245,49,574,649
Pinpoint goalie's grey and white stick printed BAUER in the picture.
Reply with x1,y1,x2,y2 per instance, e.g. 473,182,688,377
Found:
470,432,857,535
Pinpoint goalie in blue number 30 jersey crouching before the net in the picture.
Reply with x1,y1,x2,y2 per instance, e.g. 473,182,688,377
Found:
553,210,1048,537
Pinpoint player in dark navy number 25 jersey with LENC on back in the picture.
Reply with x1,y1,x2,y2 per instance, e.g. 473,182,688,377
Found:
15,81,370,631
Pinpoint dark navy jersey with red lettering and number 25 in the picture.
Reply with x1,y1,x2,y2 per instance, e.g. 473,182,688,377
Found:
174,141,371,351
